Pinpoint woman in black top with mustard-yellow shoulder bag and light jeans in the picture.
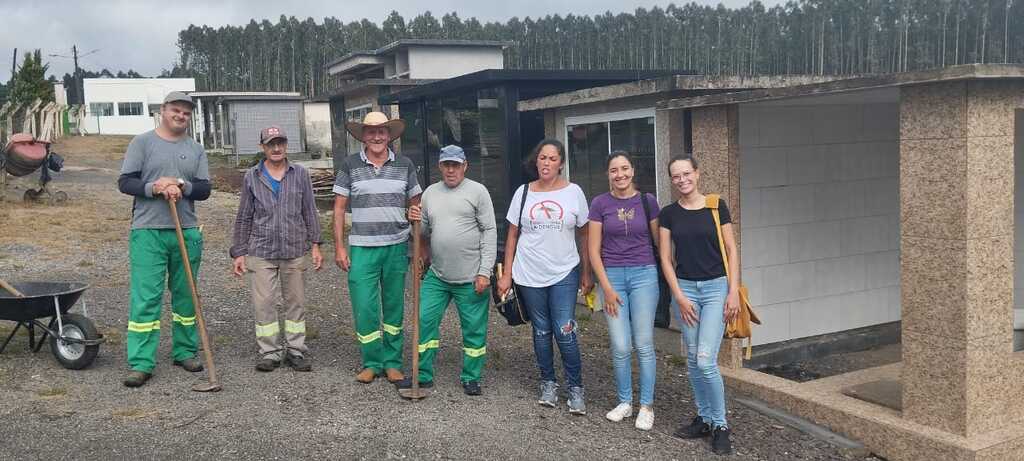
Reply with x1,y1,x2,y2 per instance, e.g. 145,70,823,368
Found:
658,156,739,455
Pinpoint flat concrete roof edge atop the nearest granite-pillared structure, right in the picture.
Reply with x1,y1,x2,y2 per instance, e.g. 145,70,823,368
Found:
657,64,1024,110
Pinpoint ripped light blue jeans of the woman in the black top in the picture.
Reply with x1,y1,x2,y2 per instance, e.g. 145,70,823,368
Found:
672,277,729,427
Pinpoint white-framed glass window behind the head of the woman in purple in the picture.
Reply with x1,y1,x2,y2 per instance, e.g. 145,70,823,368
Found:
567,117,656,200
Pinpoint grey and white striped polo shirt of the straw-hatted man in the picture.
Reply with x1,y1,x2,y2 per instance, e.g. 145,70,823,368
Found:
334,150,423,247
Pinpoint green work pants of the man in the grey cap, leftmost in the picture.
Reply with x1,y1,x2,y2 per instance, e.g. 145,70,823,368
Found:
126,227,203,373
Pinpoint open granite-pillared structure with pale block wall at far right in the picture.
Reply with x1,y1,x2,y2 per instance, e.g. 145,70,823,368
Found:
657,65,1024,460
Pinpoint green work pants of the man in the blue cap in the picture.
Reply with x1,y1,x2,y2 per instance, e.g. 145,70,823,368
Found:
418,270,489,382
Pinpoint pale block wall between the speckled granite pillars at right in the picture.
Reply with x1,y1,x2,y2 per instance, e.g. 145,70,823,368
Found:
739,102,900,344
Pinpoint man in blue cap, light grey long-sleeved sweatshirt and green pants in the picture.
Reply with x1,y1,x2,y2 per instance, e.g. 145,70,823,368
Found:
398,145,498,395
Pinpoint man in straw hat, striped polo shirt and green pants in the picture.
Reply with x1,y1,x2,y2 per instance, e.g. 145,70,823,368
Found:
334,112,423,384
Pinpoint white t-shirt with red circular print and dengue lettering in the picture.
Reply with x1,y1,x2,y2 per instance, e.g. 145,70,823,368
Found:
505,183,589,288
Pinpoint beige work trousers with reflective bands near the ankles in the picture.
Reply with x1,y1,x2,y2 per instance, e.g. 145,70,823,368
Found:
246,256,309,361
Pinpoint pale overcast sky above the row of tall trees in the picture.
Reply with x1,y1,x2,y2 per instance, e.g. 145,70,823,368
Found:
0,0,780,82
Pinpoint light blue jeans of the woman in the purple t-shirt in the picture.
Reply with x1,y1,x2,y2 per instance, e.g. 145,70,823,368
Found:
598,264,658,406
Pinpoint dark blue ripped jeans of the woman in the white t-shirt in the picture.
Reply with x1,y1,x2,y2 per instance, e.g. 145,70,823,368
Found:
517,267,583,387
